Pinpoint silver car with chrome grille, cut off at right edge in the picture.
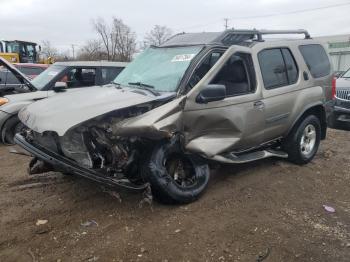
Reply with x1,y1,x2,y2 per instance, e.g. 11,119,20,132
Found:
328,69,350,129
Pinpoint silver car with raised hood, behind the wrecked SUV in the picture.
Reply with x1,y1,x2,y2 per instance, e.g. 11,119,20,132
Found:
0,58,127,144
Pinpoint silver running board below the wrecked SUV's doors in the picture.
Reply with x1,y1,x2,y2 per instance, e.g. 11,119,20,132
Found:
212,149,288,164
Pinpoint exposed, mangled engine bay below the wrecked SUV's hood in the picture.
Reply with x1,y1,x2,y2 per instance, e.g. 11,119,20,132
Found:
24,103,164,181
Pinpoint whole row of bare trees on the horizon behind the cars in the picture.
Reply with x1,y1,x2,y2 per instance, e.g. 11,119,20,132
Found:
41,17,172,62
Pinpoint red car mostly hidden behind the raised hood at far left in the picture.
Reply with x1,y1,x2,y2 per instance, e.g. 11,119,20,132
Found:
0,63,49,94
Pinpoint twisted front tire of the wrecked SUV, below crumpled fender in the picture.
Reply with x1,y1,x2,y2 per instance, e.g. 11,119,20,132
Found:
141,141,210,204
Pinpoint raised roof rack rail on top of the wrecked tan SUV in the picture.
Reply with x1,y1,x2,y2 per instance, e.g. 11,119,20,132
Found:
222,29,311,42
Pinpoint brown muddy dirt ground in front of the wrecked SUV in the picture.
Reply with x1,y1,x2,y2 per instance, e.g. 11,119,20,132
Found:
0,130,350,262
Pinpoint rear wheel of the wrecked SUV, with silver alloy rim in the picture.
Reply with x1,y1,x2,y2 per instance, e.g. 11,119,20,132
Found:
283,115,321,165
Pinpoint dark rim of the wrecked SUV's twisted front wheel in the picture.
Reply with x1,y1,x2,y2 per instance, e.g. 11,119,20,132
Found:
165,155,197,188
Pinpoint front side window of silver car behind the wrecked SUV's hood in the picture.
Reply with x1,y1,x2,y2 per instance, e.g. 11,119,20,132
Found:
59,68,96,88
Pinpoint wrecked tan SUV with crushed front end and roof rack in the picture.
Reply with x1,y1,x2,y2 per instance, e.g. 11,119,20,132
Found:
15,30,332,203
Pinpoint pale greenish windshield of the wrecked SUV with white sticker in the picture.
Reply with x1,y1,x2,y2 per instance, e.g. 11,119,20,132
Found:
114,46,202,92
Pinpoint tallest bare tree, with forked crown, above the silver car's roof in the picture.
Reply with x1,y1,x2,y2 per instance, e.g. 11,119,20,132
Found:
93,17,136,61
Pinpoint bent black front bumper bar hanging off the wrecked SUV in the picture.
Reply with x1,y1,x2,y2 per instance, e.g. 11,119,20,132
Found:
15,134,148,191
